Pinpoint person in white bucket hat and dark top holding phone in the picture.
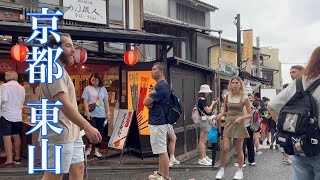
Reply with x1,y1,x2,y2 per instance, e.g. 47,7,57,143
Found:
198,84,218,166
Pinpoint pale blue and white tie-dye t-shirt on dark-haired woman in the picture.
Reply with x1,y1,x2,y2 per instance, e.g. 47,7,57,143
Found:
82,86,108,118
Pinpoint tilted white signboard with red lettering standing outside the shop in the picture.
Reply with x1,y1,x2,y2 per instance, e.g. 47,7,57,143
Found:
108,109,133,150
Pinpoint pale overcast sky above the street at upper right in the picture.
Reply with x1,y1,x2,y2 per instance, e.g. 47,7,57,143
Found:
203,0,320,83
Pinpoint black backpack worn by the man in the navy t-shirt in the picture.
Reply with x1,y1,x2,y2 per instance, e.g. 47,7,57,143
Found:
161,84,182,124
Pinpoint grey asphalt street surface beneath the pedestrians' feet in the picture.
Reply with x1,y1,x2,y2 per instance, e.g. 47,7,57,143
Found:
0,149,292,180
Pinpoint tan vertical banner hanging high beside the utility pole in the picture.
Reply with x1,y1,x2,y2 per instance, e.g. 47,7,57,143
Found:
242,30,253,74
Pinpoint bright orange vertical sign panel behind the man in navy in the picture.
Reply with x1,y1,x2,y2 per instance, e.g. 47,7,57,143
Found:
128,71,156,135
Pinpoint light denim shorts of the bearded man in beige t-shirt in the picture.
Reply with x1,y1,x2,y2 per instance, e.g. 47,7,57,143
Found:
48,139,84,174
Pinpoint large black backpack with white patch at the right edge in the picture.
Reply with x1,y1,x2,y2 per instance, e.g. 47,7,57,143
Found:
277,78,320,157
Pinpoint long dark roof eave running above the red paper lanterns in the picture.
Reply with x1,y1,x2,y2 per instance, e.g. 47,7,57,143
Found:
0,21,187,45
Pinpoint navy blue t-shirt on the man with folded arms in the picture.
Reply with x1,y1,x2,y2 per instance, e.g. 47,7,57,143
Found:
149,80,170,125
